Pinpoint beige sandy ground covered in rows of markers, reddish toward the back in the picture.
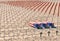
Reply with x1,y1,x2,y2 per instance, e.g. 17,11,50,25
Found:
0,1,60,41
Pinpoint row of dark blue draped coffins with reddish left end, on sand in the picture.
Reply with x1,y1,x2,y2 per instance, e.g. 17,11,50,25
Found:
29,22,56,29
